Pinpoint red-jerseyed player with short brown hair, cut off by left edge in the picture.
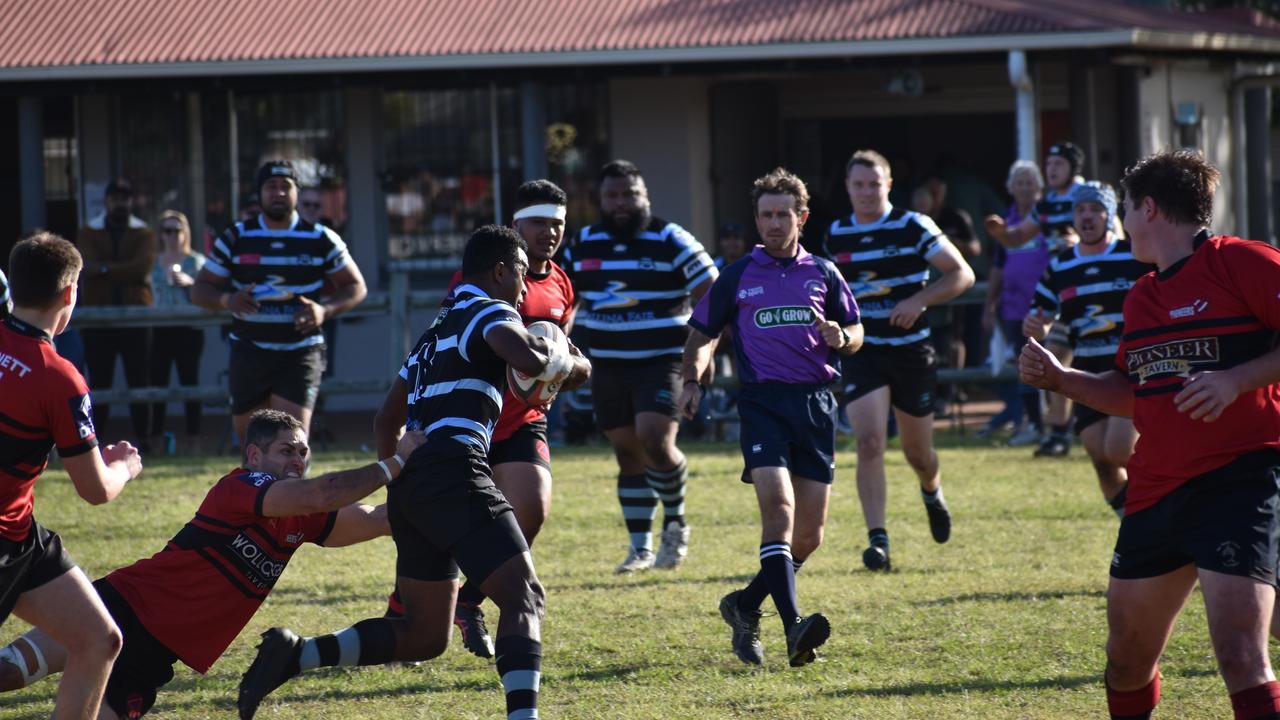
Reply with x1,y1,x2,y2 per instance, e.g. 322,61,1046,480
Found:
0,233,142,717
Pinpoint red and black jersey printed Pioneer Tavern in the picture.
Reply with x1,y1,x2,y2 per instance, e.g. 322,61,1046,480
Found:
1116,232,1280,512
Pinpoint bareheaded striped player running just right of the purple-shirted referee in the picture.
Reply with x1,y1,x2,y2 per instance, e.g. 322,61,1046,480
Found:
827,150,973,570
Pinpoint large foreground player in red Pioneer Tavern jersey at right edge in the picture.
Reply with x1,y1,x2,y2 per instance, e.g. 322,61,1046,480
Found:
1019,150,1280,719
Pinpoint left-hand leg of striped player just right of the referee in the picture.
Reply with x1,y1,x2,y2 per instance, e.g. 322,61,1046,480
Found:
845,387,892,570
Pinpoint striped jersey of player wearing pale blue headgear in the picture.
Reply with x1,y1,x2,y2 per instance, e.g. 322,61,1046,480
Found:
1032,240,1155,373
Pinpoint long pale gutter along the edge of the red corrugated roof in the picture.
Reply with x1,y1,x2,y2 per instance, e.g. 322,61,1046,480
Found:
0,28,1280,82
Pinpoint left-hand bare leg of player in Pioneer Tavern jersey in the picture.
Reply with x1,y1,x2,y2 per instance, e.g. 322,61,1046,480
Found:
1106,565,1196,711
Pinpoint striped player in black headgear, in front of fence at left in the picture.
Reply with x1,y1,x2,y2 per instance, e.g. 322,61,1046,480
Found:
191,160,369,438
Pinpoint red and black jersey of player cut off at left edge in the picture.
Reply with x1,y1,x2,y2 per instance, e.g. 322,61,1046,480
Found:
0,315,97,541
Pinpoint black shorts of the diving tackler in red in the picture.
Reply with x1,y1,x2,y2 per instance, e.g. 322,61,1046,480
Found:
93,578,178,717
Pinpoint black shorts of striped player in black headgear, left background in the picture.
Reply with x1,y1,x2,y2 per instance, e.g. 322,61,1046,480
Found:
227,340,325,415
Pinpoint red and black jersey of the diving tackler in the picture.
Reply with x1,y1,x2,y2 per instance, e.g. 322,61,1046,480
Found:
106,468,338,673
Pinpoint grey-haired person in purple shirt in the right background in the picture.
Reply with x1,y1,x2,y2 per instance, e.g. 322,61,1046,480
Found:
979,160,1051,446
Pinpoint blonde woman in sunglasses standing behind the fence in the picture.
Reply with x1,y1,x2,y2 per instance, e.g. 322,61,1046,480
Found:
151,210,205,450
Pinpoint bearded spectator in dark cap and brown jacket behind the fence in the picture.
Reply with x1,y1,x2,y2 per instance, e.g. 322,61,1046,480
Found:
76,178,156,454
